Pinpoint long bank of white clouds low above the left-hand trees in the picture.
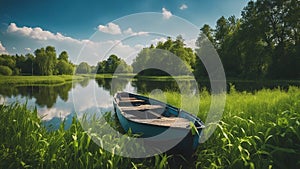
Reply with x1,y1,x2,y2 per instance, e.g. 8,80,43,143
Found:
6,23,147,65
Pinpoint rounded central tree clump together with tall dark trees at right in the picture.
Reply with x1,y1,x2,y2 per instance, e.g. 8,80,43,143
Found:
132,0,300,79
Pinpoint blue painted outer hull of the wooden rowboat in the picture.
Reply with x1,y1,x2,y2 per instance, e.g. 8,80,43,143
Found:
113,92,204,154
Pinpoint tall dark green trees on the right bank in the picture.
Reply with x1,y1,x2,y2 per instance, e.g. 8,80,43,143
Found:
195,0,300,79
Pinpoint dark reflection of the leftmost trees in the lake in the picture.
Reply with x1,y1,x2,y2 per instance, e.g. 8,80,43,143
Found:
0,83,72,108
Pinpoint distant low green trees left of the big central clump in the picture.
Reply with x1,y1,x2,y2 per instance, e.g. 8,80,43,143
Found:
0,46,132,76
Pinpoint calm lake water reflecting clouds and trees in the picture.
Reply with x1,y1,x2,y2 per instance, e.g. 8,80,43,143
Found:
0,78,299,128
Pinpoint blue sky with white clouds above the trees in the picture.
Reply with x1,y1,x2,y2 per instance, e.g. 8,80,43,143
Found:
0,0,248,65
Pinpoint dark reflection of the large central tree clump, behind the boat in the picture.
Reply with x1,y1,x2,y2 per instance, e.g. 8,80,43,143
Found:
131,79,197,93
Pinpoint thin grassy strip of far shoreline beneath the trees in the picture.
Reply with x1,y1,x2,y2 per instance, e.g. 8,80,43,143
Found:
0,74,300,86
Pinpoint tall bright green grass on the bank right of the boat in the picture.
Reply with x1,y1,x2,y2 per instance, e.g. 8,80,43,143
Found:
151,86,300,169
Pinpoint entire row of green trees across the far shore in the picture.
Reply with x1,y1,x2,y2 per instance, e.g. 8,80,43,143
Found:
0,0,300,79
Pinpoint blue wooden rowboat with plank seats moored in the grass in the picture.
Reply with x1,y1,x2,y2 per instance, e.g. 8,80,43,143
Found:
113,92,204,153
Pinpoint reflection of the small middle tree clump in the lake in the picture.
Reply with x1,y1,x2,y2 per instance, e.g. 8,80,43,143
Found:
95,78,130,95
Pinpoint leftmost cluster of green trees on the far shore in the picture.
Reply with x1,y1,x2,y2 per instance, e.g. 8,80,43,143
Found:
0,46,75,76
